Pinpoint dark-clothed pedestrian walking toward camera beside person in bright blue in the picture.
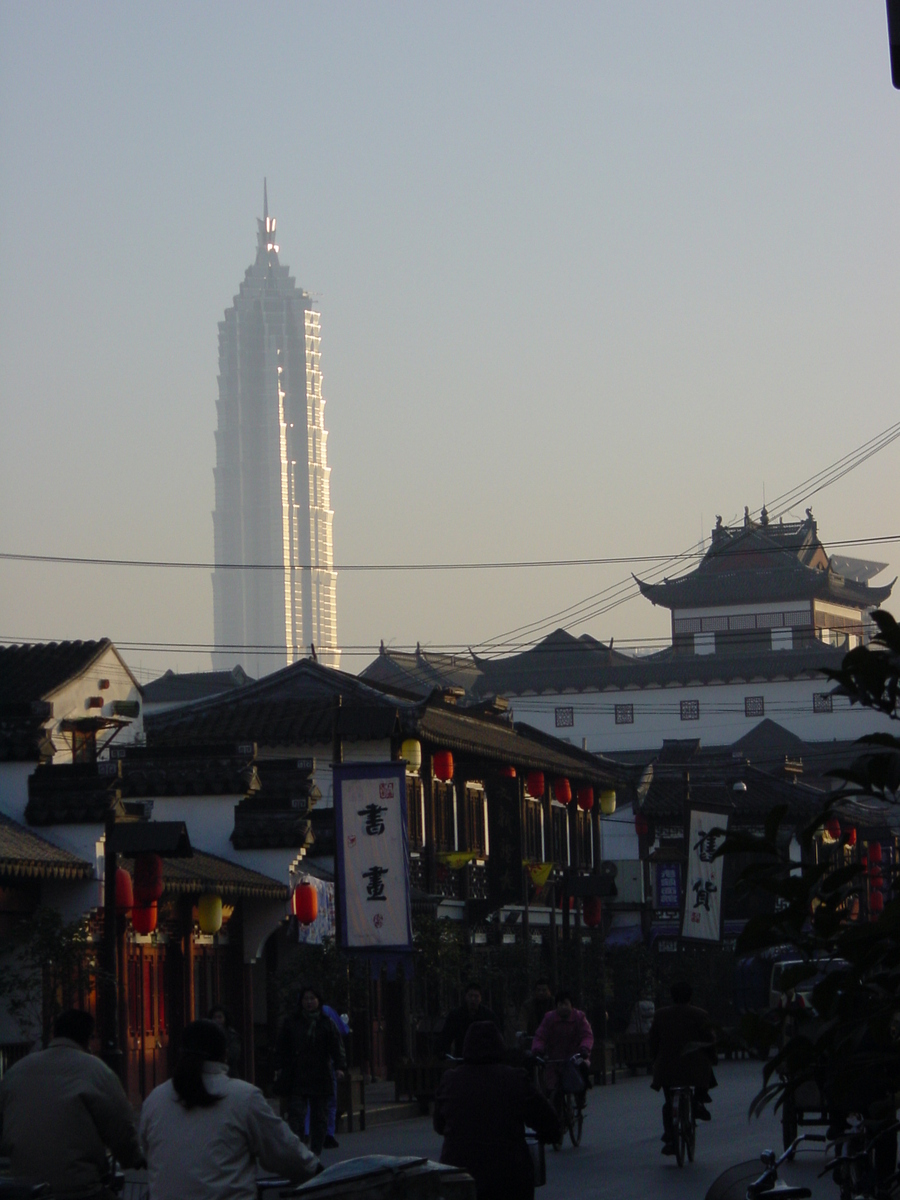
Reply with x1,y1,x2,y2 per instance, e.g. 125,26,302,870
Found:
275,984,347,1154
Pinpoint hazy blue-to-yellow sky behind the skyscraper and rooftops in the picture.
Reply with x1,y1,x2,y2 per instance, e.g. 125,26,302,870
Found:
0,0,900,676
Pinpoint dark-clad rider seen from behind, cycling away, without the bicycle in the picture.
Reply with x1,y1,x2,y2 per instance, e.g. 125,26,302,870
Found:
650,982,719,1154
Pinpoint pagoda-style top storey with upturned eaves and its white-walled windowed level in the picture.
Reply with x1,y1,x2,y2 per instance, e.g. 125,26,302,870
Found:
636,509,893,655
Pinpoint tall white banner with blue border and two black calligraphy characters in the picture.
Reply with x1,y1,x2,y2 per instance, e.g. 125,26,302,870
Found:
334,762,413,952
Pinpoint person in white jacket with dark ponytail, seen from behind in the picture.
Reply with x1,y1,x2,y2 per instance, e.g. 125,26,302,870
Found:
138,1021,322,1200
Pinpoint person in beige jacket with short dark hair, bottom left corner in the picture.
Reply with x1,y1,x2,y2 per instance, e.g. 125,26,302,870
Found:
0,1008,143,1200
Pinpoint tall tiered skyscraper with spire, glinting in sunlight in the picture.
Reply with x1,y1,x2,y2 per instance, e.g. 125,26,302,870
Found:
212,185,340,676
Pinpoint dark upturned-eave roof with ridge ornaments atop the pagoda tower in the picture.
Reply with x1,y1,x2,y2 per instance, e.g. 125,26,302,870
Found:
635,510,893,610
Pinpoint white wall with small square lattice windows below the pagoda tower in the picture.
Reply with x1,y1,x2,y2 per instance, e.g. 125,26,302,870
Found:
510,679,892,754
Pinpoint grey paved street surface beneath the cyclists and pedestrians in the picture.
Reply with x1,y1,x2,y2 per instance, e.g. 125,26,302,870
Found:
323,1062,838,1200
